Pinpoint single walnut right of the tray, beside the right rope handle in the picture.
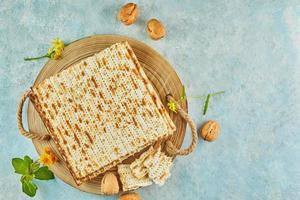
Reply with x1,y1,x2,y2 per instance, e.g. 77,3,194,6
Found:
199,120,220,142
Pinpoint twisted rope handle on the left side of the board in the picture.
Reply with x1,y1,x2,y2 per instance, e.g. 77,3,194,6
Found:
17,90,50,140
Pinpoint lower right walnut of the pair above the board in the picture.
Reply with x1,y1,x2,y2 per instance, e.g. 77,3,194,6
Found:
147,19,166,40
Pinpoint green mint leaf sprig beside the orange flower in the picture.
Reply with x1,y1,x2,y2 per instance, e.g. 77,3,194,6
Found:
12,156,54,197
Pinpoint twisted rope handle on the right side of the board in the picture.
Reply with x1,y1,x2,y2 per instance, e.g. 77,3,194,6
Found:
166,94,198,156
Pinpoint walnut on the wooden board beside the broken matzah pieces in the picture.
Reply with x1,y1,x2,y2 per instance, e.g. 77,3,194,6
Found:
100,172,119,195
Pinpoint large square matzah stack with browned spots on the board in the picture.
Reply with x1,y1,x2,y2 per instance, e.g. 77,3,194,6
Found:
30,42,175,184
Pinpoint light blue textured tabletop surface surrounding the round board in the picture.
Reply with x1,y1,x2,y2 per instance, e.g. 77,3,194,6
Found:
0,0,300,200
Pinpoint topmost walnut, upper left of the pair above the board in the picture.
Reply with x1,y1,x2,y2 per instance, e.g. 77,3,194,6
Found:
118,3,139,25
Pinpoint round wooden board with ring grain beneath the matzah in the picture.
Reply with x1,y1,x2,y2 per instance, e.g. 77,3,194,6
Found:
27,35,187,194
